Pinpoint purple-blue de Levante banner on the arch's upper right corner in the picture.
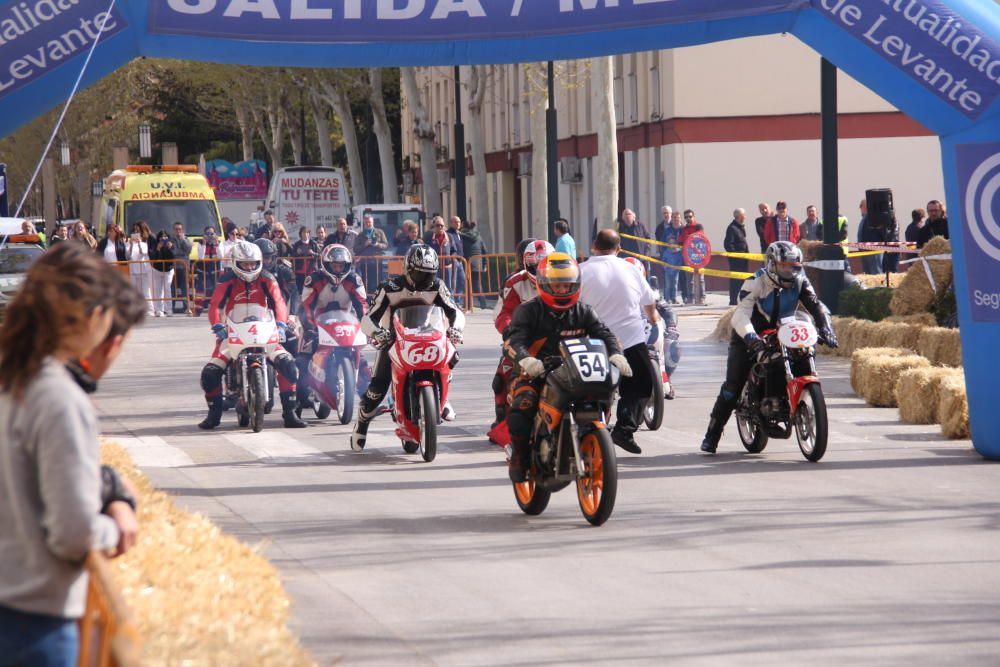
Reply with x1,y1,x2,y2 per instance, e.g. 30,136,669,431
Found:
812,0,1000,118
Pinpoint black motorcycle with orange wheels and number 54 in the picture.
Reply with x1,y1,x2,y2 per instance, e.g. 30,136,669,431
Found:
513,338,619,526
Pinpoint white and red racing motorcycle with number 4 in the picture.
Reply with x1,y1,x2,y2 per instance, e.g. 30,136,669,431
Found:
226,303,281,433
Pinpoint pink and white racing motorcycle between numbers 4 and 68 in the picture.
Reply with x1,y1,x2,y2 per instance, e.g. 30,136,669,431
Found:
306,310,368,424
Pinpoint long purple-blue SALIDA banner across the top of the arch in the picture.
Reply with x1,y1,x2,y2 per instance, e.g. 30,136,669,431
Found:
148,0,807,43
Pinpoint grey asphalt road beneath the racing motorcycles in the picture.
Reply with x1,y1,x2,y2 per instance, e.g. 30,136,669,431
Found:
98,300,1000,665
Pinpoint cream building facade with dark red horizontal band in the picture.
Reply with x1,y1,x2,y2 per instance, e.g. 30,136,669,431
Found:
403,35,944,251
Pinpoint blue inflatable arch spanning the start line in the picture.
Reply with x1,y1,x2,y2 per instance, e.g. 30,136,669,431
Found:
0,0,1000,459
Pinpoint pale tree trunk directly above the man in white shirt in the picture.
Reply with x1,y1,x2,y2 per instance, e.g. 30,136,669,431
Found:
585,56,618,235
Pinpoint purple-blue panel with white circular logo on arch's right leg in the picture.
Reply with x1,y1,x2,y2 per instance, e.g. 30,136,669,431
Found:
955,143,1000,322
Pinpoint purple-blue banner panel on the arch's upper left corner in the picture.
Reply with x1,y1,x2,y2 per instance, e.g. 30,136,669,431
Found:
0,0,127,99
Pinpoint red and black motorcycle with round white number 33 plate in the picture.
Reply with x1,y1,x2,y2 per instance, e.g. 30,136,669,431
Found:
736,311,828,462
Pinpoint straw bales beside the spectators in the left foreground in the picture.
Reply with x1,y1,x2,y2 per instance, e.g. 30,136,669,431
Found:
102,443,315,667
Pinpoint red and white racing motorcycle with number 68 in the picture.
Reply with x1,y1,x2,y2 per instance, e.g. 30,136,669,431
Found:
389,305,455,462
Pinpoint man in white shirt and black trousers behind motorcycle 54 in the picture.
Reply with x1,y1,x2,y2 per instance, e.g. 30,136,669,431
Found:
580,229,660,454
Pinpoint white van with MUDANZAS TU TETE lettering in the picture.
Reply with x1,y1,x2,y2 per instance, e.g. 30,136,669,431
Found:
267,167,351,237
